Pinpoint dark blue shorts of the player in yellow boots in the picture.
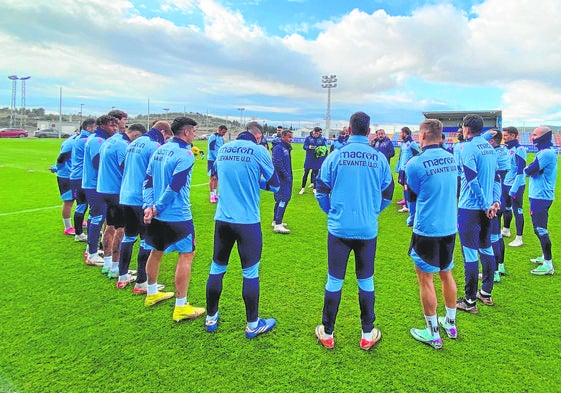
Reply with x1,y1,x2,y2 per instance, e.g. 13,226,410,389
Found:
146,218,195,254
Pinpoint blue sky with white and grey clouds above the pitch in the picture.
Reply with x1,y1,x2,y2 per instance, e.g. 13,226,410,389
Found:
0,0,561,129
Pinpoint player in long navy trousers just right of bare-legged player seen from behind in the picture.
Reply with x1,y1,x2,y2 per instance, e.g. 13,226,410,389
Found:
456,114,500,314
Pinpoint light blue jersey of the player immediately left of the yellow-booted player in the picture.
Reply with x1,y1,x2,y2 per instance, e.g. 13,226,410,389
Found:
119,128,164,206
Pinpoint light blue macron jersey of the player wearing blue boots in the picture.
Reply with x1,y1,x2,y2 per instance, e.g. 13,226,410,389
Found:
214,132,279,224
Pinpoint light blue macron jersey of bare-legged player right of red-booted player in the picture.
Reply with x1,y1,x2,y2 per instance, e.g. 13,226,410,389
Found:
405,145,458,237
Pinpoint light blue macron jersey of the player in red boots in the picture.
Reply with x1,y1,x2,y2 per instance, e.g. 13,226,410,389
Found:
316,135,393,240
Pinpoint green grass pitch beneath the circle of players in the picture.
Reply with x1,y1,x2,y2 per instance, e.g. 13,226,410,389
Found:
0,140,561,392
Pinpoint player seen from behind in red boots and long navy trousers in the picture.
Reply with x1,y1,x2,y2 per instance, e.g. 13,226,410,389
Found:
315,112,393,350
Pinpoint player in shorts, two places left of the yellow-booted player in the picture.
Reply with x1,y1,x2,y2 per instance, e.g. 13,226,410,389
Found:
96,124,146,280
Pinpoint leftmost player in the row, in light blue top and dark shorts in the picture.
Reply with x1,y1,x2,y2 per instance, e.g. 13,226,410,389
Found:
51,130,82,236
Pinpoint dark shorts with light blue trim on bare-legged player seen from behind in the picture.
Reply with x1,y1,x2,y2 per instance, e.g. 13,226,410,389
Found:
409,233,456,273
